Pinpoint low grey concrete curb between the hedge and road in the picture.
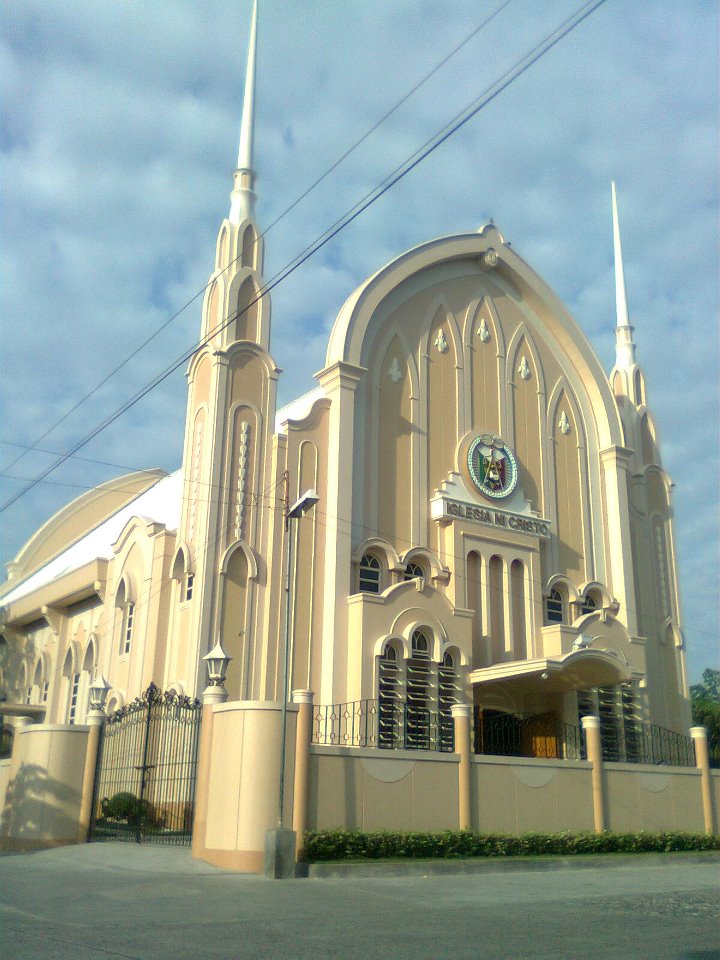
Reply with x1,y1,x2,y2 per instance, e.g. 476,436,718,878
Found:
305,850,720,880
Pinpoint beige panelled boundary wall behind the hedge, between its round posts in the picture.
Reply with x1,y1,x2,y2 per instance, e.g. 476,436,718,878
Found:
308,745,720,834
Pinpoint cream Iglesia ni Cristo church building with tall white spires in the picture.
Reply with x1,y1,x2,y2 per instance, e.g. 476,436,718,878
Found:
0,5,690,780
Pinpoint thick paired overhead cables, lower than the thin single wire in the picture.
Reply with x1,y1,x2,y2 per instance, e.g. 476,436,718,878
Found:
0,0,606,513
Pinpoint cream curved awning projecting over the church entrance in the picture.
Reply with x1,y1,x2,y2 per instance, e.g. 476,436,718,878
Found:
470,650,632,694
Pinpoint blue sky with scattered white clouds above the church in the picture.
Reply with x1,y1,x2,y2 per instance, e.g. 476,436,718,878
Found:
0,0,720,680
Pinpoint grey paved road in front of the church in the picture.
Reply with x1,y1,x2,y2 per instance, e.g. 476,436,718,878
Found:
0,844,720,960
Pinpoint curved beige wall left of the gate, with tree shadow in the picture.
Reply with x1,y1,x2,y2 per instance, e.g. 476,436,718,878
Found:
0,724,89,850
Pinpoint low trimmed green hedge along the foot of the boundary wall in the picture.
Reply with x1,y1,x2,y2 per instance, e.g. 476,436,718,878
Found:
305,830,720,863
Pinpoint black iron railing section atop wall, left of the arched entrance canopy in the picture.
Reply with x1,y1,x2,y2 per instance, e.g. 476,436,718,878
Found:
312,700,455,753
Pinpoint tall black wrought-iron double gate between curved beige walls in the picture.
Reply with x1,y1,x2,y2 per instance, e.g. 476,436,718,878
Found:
90,683,202,844
